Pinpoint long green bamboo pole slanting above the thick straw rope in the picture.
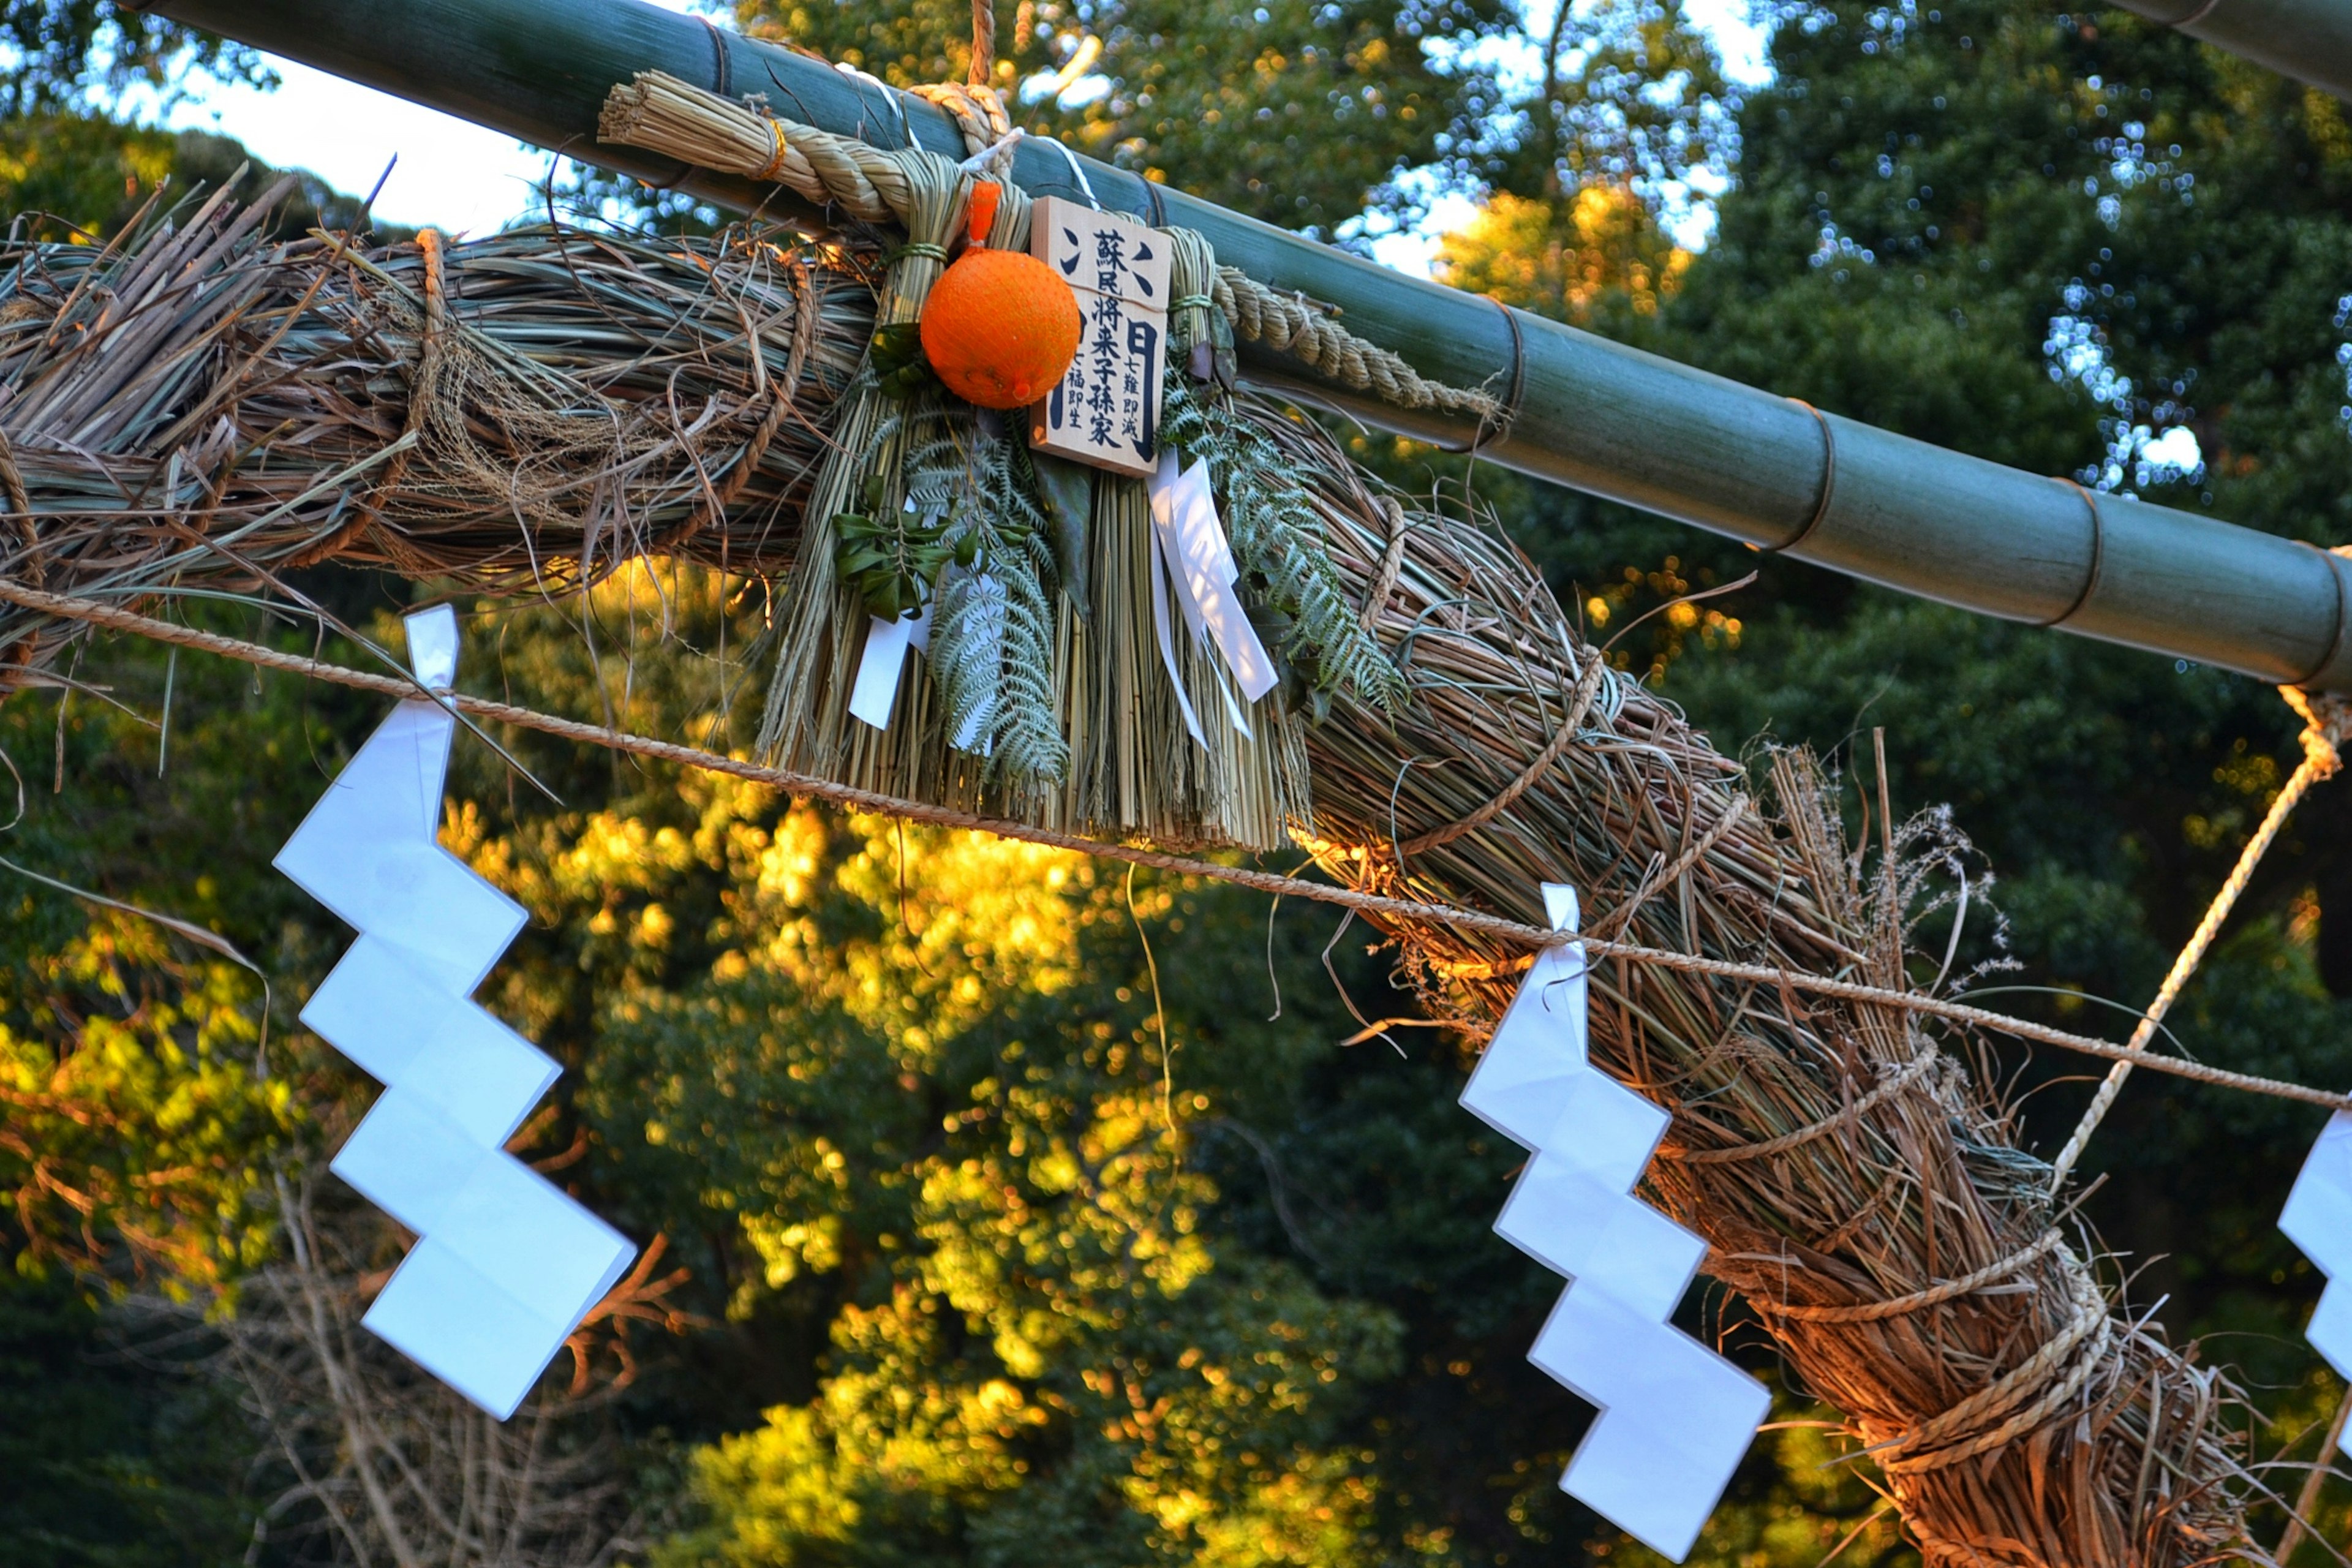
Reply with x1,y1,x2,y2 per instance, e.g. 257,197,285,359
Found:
124,0,2352,693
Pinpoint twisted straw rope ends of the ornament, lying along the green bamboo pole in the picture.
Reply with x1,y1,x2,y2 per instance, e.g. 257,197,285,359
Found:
597,70,1498,421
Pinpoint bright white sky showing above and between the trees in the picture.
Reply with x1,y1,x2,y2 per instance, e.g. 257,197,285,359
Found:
129,0,1764,273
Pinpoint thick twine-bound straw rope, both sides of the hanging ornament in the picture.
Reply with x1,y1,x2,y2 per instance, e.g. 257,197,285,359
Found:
0,104,2323,1568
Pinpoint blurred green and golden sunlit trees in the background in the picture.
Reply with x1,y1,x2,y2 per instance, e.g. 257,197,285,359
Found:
0,0,2352,1568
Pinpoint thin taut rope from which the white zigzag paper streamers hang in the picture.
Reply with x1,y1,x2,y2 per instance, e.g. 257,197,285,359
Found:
18,581,2352,1110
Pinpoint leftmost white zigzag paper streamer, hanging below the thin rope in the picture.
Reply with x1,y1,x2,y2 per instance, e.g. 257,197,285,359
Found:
275,606,638,1420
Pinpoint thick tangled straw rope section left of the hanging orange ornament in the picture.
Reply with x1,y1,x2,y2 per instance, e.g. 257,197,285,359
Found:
0,177,873,691
